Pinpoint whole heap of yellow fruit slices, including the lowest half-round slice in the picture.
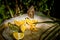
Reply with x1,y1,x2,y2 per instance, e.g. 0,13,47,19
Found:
8,18,38,40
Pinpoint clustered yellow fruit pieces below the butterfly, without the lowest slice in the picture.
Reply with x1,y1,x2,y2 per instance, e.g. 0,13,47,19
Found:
14,18,38,32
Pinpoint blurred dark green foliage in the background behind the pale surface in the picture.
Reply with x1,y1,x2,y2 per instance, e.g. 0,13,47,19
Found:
0,0,54,23
